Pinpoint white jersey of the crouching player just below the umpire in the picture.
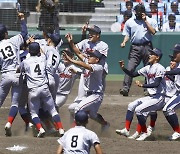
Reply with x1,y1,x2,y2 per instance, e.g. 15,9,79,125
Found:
138,63,166,95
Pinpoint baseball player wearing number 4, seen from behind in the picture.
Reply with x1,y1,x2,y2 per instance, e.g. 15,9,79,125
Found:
21,42,64,137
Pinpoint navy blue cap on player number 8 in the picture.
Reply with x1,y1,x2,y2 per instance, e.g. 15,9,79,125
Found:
75,110,89,123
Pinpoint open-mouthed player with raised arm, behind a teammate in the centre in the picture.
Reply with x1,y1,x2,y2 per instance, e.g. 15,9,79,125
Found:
67,24,109,128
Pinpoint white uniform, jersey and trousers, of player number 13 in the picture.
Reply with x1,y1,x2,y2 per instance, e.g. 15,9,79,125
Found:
0,34,24,106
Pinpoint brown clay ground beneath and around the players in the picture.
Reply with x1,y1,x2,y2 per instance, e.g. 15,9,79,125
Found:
0,81,180,154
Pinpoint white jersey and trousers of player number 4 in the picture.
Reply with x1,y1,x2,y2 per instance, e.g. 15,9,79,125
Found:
21,55,58,119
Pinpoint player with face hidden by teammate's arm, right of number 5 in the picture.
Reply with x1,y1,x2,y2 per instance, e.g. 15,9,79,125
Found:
56,48,82,108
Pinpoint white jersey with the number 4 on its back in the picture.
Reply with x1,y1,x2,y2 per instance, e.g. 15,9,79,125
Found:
21,55,48,89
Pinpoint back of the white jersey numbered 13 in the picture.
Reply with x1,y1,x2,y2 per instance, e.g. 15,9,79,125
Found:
0,40,18,72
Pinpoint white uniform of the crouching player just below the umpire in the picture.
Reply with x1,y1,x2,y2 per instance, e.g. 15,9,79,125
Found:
128,63,166,116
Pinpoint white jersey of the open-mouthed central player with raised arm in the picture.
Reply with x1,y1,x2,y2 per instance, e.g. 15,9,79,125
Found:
76,39,109,57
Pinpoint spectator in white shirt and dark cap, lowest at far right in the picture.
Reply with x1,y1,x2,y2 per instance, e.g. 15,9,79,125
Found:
162,14,180,32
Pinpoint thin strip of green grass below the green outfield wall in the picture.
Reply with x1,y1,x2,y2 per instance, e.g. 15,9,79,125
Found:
106,74,144,81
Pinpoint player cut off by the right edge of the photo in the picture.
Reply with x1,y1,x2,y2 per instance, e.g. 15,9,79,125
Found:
163,44,180,140
